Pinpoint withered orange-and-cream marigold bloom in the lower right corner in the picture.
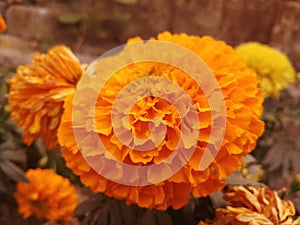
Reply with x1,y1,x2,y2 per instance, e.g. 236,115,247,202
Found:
199,186,300,225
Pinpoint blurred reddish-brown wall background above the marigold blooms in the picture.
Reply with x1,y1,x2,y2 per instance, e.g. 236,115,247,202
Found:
0,0,300,71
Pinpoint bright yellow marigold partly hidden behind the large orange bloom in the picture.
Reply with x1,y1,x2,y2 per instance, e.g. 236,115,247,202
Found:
236,42,296,97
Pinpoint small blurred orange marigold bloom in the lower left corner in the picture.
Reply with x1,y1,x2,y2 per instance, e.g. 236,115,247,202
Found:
14,168,78,221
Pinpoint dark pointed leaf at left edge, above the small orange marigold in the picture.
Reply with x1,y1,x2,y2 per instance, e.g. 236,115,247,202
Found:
0,161,28,183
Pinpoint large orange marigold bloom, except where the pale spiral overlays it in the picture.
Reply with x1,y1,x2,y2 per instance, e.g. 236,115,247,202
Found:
58,32,264,210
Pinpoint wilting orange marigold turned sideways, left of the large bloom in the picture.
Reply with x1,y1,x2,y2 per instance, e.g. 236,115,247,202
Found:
8,46,83,149
